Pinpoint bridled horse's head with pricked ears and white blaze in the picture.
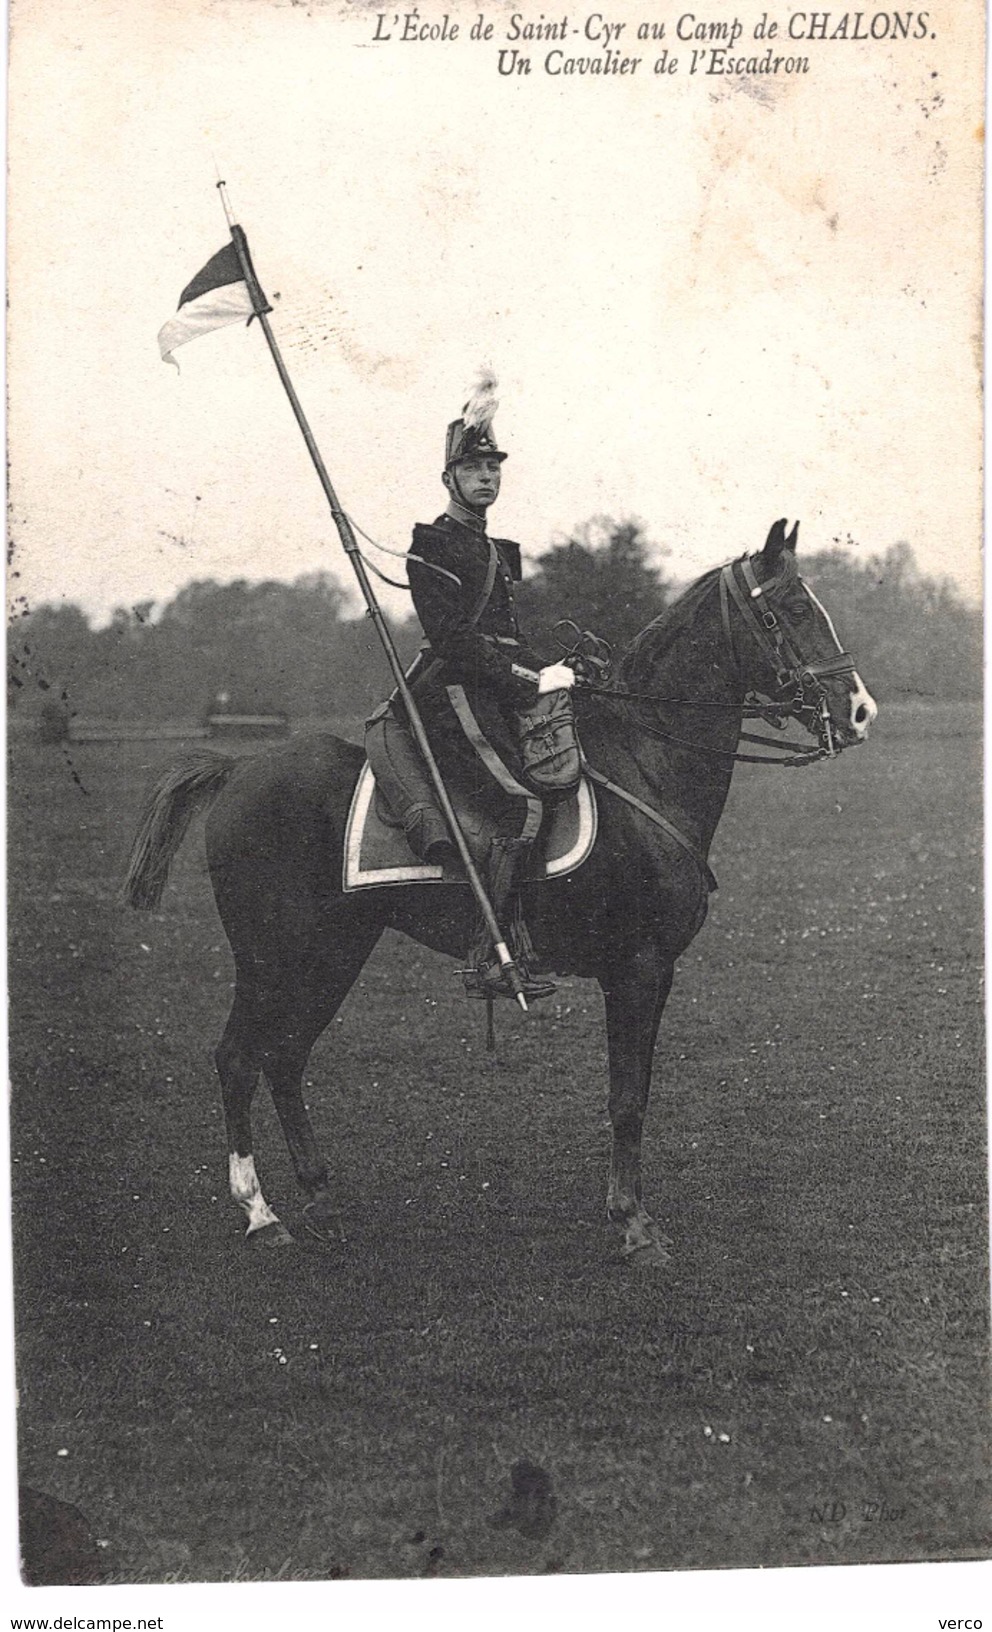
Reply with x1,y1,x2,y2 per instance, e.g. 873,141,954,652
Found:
721,521,878,752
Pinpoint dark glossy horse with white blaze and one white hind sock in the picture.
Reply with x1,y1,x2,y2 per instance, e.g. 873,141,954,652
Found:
124,521,878,1257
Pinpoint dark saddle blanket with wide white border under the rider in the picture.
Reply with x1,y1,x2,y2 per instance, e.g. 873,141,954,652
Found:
343,762,597,889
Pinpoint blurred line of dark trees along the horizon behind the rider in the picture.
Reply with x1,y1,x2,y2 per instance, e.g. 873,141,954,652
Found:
8,517,982,720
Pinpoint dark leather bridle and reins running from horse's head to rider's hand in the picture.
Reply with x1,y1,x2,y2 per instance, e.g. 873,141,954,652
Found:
569,555,855,767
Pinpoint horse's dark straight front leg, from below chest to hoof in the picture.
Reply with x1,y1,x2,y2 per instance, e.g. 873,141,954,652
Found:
602,947,674,1257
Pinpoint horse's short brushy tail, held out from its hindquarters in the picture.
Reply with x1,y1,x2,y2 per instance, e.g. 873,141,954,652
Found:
121,749,238,909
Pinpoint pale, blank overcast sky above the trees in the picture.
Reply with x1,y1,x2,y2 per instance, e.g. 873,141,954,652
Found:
10,0,981,617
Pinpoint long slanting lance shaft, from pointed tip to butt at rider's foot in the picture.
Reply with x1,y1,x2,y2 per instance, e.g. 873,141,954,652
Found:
217,181,527,1012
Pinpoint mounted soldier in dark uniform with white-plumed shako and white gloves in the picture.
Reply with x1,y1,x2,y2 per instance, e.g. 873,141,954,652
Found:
365,374,579,1000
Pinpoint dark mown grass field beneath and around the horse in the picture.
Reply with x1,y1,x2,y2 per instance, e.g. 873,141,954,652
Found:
10,707,990,1581
